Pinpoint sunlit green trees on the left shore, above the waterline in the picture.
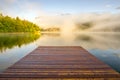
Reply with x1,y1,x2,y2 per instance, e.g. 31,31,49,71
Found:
0,14,40,32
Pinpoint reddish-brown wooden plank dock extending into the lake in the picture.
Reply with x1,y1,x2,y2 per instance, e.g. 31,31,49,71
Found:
0,46,120,80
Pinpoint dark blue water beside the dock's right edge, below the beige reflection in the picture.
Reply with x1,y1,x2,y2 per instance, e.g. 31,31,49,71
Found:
89,49,120,72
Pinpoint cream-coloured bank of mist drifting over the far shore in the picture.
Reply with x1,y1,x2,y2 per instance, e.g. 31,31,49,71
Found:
36,13,120,33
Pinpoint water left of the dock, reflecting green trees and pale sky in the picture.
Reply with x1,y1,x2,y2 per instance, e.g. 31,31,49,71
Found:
0,33,40,72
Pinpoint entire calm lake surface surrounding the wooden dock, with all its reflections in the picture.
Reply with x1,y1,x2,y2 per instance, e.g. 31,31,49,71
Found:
0,33,120,72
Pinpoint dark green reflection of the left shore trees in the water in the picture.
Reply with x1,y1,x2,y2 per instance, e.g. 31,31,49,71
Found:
0,33,40,52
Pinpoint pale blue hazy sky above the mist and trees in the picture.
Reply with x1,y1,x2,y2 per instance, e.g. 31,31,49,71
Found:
0,0,120,21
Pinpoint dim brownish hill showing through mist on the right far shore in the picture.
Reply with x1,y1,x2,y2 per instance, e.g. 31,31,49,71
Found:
76,22,120,32
